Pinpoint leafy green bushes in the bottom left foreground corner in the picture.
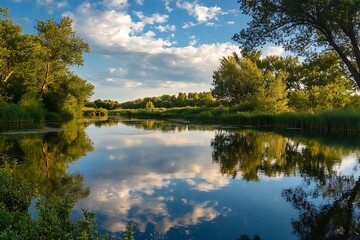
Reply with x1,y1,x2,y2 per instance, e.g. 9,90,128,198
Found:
0,164,107,240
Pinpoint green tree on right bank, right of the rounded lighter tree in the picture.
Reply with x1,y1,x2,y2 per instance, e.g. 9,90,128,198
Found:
289,53,355,112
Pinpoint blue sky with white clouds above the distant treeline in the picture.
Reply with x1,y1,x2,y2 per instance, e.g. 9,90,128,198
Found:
0,0,283,102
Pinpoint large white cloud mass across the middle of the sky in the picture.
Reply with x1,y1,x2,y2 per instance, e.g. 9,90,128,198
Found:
64,2,238,97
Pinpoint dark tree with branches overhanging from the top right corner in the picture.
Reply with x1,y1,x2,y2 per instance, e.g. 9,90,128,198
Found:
233,0,360,88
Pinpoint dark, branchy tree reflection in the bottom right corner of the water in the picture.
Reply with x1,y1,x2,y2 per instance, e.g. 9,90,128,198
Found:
283,162,360,240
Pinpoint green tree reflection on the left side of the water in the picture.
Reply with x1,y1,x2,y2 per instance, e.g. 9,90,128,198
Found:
0,121,93,204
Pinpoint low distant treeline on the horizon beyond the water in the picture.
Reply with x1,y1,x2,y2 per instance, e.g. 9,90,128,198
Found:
86,92,219,110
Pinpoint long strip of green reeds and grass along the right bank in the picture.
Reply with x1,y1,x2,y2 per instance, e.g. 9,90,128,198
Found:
109,107,360,132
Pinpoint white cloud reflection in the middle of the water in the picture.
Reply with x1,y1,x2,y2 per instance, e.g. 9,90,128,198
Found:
74,128,230,234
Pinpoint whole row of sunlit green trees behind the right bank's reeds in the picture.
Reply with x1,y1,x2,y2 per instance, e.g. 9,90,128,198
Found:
211,52,357,113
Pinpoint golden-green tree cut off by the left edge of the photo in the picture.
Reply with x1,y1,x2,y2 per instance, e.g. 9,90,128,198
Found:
0,7,40,103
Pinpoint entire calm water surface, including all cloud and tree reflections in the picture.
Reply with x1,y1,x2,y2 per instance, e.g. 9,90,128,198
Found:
0,120,360,240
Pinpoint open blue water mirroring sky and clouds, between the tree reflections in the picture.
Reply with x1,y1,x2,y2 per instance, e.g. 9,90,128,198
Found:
68,122,355,239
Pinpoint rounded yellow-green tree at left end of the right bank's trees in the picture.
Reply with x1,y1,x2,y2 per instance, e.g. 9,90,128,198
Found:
211,52,288,112
